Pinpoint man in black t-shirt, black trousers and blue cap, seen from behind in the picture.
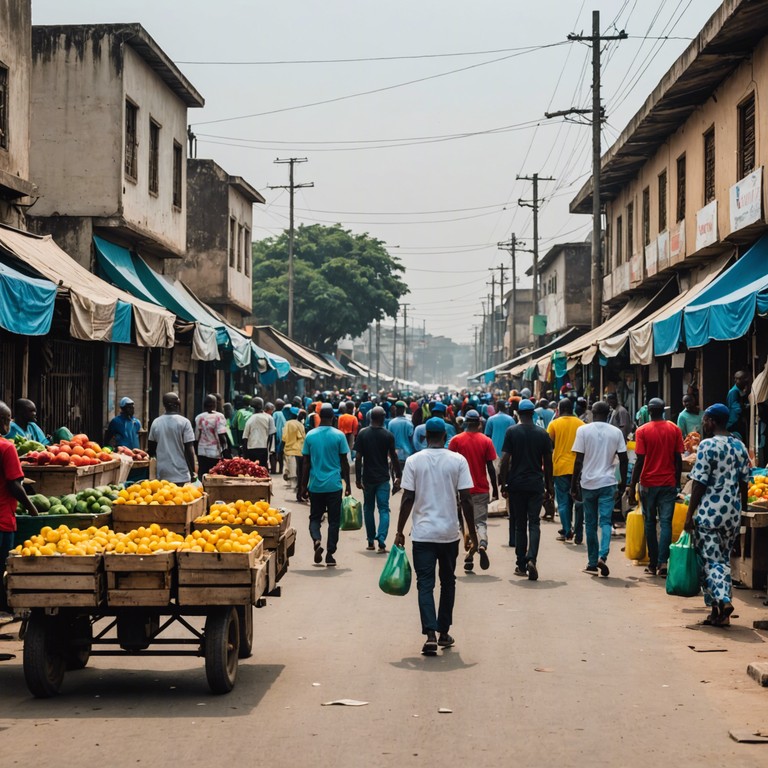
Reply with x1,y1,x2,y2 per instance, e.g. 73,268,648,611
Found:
499,400,552,581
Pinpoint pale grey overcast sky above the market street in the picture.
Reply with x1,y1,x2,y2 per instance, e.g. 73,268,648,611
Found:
33,0,720,341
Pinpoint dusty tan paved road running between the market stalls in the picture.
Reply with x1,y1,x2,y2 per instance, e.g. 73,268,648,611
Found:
0,481,768,768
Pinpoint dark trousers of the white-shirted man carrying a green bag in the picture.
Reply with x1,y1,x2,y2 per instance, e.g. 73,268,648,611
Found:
413,541,459,635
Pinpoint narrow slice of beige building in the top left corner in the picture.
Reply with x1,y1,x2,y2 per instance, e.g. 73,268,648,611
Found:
0,0,38,229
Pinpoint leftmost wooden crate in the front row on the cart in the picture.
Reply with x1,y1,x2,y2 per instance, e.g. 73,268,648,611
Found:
6,555,105,611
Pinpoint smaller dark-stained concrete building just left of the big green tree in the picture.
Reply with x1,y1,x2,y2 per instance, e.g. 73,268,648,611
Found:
181,158,265,327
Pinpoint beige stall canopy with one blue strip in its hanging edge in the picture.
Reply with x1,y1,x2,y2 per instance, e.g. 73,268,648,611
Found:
0,227,174,347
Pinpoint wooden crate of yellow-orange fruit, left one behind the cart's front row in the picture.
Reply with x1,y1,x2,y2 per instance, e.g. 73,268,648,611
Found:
112,480,206,534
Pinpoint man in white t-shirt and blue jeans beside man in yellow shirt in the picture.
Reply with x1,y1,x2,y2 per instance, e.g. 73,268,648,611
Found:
571,400,627,576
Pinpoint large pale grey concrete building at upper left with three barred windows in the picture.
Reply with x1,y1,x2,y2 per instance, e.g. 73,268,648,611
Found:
30,24,204,272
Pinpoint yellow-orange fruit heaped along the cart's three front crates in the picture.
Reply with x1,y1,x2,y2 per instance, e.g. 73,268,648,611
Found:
13,523,261,557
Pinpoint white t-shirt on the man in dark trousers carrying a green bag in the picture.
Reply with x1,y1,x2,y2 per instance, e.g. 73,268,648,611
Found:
402,448,474,544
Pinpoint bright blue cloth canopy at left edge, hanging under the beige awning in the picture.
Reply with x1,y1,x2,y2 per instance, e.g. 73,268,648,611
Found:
0,255,56,336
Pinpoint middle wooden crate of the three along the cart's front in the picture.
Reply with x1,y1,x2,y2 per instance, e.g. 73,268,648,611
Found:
104,552,176,607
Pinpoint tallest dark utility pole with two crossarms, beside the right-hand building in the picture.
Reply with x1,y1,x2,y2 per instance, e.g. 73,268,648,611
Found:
545,11,627,328
